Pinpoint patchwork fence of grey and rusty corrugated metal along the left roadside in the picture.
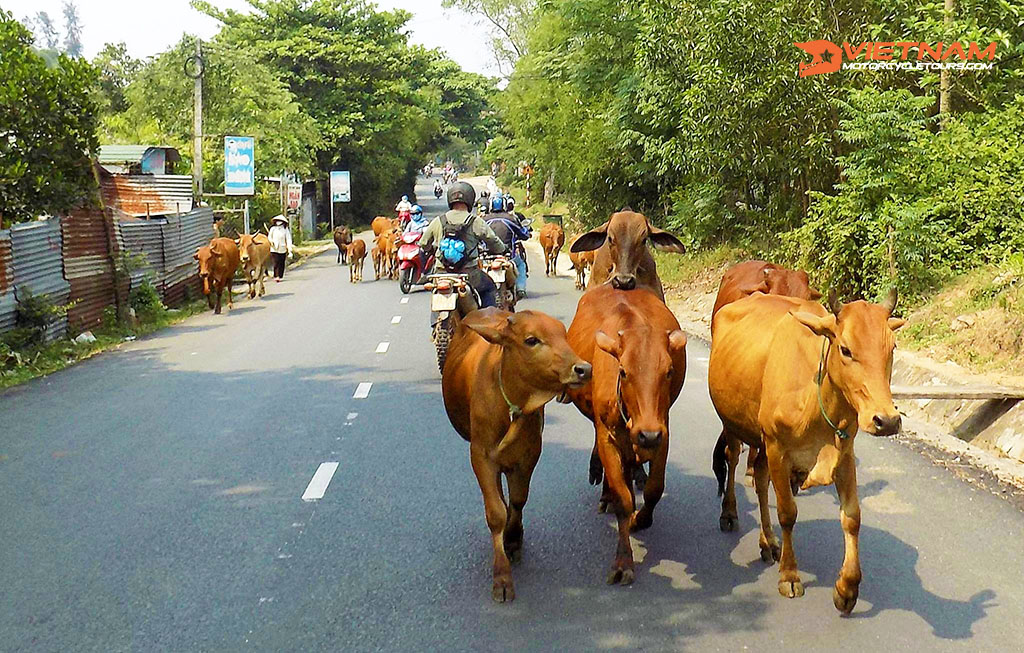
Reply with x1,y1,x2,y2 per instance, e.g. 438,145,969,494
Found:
0,208,213,340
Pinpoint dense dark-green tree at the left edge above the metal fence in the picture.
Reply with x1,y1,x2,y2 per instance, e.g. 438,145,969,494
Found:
0,10,98,226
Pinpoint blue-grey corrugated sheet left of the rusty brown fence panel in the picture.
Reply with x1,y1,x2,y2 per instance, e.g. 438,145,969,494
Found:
10,218,71,340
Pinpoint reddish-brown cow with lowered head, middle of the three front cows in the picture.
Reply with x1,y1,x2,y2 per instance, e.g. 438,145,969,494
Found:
568,286,686,584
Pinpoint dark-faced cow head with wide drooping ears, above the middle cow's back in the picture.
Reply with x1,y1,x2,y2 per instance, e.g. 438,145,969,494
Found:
569,210,685,291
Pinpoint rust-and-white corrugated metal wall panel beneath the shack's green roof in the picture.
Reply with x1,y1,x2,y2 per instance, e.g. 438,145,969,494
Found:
99,171,193,217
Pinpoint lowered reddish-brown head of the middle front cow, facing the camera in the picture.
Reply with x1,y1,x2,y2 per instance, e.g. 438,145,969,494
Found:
597,327,686,449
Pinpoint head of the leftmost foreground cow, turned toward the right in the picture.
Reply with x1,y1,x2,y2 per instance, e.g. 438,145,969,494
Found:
463,308,591,405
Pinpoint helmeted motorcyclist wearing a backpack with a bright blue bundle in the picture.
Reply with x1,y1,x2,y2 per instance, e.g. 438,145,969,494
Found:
420,181,506,308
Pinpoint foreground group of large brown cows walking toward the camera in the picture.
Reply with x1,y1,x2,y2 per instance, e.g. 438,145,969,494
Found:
442,211,903,614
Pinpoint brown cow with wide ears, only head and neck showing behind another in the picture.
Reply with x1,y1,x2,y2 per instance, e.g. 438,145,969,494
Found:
569,209,684,301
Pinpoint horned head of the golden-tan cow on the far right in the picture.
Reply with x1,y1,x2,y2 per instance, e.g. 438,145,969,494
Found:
791,289,906,436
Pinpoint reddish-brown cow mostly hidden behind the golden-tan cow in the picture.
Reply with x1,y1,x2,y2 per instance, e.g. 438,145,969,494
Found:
711,261,821,485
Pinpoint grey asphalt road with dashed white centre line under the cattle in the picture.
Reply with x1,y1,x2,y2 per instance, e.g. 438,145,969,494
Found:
0,176,1024,651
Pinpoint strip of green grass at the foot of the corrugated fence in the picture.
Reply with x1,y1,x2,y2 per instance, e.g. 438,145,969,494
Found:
0,298,208,389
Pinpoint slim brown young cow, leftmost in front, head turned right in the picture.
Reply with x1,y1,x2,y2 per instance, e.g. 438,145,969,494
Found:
441,308,591,603
